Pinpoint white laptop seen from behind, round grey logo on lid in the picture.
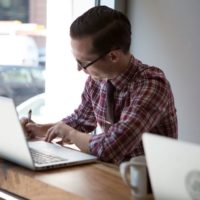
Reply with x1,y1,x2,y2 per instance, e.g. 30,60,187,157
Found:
142,133,200,200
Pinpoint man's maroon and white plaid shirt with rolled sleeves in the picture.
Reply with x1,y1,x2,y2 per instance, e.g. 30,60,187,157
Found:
63,58,177,164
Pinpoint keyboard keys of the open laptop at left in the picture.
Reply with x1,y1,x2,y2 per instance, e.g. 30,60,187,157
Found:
30,148,66,164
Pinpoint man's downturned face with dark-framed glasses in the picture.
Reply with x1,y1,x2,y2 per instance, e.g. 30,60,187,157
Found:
71,37,112,80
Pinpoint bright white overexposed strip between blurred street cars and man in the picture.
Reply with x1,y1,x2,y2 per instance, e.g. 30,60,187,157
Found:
44,0,94,122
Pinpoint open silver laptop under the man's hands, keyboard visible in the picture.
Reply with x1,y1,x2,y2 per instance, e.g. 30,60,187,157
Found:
0,97,97,170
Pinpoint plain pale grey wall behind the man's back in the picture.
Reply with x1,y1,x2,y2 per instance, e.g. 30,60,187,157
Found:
127,0,200,143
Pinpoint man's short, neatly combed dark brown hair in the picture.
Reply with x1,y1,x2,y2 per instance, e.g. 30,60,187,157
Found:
70,6,131,54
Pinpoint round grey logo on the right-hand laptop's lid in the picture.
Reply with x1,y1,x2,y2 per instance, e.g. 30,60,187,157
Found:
185,170,200,200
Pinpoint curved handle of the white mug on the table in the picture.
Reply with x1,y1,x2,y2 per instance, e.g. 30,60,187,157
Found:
120,161,145,192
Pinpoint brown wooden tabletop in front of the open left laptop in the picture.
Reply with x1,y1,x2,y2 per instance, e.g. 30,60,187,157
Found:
0,160,153,200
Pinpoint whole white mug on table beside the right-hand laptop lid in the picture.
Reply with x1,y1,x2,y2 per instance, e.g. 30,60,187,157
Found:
120,156,152,199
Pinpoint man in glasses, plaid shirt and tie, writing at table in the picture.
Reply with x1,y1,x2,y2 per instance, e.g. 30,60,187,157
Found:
21,6,177,164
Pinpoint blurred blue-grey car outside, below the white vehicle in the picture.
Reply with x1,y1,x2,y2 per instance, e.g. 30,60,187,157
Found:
0,66,45,105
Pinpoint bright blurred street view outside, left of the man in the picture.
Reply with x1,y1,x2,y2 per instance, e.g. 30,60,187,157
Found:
0,0,108,122
